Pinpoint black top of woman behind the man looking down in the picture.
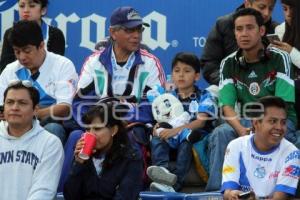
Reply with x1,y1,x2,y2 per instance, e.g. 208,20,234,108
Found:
0,26,65,74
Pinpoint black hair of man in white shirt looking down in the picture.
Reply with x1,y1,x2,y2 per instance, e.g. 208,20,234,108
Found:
9,20,44,47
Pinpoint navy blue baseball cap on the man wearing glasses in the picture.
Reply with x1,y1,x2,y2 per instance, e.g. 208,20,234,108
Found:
110,6,149,28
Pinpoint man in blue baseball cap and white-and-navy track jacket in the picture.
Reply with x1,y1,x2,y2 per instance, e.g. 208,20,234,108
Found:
60,7,165,193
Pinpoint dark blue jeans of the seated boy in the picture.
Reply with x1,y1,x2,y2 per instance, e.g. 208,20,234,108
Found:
151,136,192,191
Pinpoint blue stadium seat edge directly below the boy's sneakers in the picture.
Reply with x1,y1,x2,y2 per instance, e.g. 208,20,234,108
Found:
139,192,185,200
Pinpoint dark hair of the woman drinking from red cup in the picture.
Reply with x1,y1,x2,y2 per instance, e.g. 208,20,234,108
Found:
82,102,129,168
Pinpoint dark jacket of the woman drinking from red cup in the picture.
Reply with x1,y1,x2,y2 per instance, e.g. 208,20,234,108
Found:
64,143,143,200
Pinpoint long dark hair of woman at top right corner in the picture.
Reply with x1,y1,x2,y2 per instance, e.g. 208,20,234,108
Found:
281,0,300,50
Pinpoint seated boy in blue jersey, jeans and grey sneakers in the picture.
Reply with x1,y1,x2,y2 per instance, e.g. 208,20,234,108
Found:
147,52,217,191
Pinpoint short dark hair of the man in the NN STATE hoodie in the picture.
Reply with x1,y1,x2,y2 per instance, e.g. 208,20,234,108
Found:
3,81,40,108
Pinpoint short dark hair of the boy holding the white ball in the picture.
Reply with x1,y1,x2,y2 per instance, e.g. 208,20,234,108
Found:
172,52,200,73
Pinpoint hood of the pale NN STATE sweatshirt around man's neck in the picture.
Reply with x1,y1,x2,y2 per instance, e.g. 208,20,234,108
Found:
0,120,44,140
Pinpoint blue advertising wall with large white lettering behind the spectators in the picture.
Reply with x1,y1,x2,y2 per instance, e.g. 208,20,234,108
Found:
0,0,283,87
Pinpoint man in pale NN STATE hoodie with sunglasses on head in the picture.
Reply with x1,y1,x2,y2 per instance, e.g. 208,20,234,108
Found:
0,80,64,200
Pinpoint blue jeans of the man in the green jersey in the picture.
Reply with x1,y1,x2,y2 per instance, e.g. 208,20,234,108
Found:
205,119,300,191
